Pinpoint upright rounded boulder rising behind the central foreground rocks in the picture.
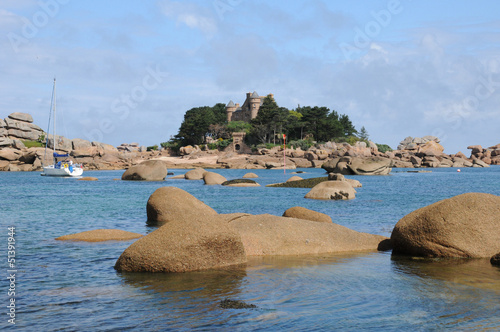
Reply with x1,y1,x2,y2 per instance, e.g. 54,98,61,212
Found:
146,187,217,224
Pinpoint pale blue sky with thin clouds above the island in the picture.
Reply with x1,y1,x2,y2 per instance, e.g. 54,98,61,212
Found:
0,0,500,154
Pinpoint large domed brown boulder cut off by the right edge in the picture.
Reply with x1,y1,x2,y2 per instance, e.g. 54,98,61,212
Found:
391,193,500,258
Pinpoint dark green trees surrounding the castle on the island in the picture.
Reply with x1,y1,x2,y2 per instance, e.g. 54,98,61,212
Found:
169,96,368,146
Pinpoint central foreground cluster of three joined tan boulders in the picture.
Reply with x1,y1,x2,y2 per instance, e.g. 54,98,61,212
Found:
115,187,387,272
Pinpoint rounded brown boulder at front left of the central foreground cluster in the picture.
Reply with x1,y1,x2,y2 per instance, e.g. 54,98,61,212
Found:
115,214,247,272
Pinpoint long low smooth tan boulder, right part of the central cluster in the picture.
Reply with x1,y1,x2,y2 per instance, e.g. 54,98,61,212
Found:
229,214,387,256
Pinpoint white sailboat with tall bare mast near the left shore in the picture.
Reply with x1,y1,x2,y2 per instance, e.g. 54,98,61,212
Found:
41,78,83,177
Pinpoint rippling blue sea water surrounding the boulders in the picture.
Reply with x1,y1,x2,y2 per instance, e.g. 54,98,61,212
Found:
0,166,500,331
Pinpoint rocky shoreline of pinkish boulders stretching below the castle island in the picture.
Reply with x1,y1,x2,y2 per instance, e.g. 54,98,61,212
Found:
0,113,500,174
